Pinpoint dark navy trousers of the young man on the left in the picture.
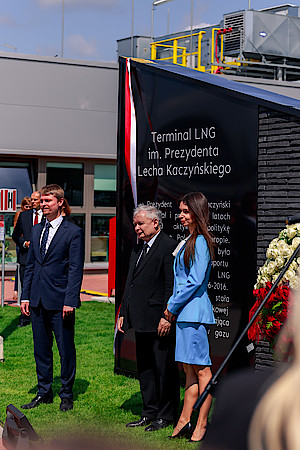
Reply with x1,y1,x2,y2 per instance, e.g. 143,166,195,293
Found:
30,302,76,398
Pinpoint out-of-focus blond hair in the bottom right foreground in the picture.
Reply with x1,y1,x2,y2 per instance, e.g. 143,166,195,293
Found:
248,291,300,450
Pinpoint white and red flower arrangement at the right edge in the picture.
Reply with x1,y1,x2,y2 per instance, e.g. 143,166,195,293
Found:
248,223,300,347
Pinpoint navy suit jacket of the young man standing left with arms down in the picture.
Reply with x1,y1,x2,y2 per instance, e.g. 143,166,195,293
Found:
21,220,84,310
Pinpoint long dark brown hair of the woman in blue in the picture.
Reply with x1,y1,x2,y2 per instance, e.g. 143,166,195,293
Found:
180,192,215,267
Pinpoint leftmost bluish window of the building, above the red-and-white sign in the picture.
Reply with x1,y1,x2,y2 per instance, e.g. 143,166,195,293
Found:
0,161,32,204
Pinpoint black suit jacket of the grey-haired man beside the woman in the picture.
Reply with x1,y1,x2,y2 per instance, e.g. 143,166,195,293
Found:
120,231,177,332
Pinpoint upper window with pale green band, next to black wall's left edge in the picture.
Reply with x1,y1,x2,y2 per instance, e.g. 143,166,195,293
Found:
94,164,117,206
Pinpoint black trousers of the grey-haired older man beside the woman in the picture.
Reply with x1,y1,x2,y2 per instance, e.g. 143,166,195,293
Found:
135,330,179,421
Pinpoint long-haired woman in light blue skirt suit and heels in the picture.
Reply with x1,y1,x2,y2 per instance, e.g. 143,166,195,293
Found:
165,192,215,442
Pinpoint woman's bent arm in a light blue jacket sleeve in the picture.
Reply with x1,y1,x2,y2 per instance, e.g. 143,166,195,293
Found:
168,235,211,314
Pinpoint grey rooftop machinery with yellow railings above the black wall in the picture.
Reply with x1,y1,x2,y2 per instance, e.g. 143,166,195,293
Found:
118,4,300,99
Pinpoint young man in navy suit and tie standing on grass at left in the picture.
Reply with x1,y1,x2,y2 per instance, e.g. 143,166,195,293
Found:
21,184,84,411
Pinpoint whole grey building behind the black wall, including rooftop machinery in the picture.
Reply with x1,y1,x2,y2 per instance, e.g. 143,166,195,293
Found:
0,4,300,269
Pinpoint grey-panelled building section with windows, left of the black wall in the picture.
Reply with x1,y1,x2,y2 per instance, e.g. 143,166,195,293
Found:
0,53,118,269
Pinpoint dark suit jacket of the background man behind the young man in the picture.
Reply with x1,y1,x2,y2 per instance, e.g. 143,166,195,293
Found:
12,209,33,265
